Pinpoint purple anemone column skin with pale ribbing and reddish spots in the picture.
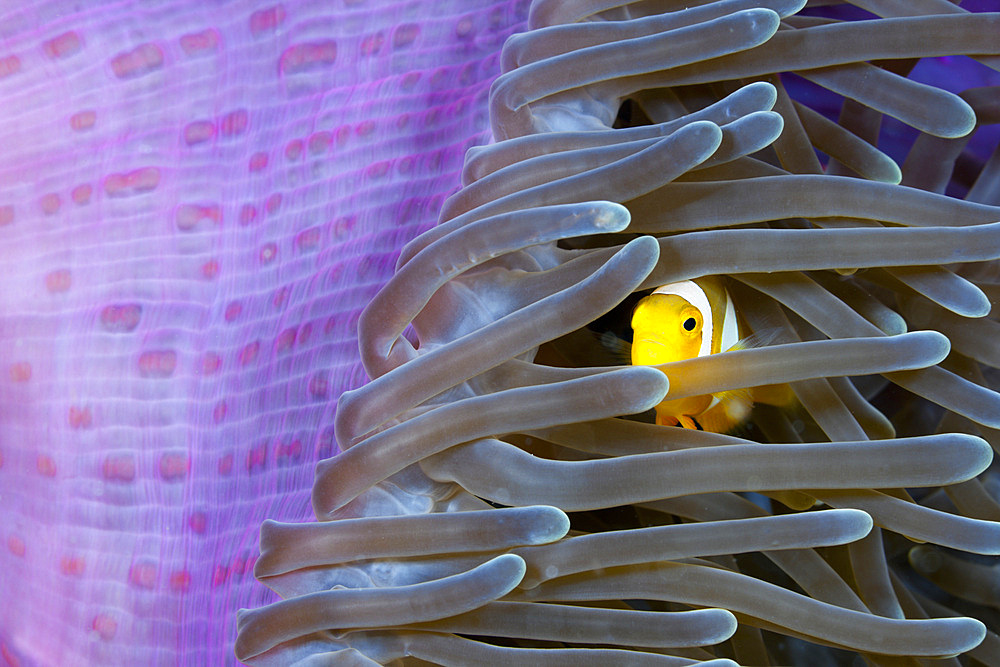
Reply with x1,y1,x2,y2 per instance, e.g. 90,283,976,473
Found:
0,0,527,665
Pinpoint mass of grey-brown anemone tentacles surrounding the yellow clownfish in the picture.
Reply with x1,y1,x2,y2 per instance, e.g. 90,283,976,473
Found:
236,0,1000,665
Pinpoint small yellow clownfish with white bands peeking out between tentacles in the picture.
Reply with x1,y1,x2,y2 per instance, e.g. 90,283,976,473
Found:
631,277,753,433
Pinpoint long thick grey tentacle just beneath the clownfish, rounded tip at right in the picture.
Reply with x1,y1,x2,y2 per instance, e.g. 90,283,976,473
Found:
421,434,988,512
